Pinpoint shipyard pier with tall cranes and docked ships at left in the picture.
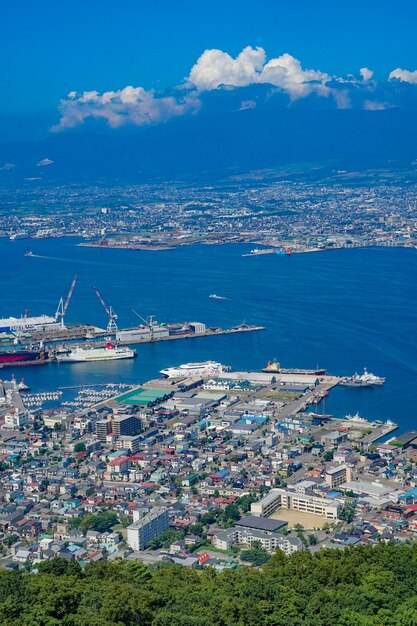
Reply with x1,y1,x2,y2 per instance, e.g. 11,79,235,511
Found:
0,275,265,368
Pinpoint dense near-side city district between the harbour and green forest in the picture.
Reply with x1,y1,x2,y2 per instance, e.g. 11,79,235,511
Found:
0,366,417,570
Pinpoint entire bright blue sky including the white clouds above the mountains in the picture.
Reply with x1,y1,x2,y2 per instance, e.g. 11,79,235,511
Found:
0,0,417,117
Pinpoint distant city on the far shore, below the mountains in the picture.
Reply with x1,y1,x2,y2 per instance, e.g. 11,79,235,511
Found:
0,181,417,252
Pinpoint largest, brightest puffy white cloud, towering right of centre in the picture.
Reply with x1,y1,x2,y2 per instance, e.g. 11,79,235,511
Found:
187,46,331,99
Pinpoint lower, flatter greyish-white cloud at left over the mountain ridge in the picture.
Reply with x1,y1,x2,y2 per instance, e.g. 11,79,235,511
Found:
52,86,200,131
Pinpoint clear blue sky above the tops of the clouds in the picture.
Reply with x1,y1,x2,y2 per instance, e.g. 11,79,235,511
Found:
0,0,417,113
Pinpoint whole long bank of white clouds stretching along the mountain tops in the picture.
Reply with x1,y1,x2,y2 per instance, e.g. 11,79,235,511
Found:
52,46,417,132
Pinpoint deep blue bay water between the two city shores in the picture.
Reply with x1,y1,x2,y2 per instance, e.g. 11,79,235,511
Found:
0,238,417,430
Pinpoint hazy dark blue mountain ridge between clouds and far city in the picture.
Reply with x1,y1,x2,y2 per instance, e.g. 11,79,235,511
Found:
0,109,417,182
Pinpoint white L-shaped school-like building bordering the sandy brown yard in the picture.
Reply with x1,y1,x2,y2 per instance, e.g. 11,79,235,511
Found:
251,489,339,520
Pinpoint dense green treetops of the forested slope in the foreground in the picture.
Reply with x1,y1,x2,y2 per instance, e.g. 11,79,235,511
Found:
0,544,417,626
